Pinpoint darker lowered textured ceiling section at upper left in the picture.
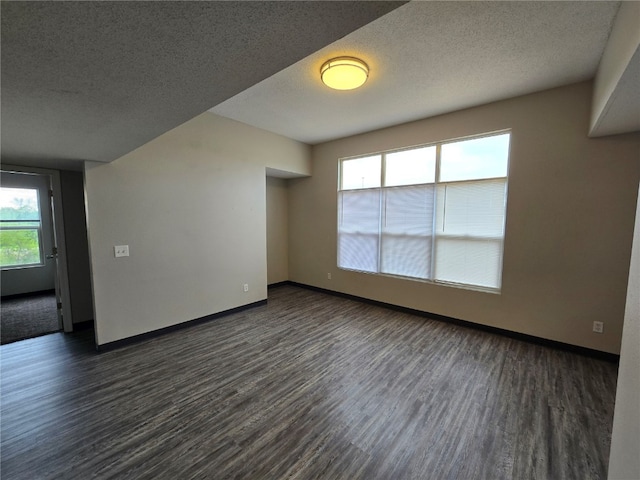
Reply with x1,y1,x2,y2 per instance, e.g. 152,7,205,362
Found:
1,1,403,168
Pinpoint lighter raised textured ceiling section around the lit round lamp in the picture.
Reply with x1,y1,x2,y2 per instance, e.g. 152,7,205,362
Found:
211,1,624,144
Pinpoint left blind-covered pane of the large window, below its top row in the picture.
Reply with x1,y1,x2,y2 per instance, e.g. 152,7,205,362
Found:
338,190,380,272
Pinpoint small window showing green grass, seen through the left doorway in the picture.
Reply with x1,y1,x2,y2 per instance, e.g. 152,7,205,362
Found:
0,187,43,268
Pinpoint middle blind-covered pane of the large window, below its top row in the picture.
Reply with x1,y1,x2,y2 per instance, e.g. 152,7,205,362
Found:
380,185,434,278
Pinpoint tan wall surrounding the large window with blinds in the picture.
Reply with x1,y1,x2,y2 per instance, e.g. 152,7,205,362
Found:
289,82,640,354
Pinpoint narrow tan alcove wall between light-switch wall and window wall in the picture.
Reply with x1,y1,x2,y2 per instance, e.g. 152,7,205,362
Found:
267,177,289,285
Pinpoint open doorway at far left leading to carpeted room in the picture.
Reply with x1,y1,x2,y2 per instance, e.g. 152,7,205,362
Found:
0,167,71,344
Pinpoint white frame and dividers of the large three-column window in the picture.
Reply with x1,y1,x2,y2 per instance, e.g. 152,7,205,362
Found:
336,128,512,294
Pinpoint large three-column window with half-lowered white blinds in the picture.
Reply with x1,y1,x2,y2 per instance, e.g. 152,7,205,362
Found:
338,133,510,290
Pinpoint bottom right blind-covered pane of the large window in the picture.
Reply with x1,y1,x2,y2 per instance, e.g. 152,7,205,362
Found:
434,237,502,288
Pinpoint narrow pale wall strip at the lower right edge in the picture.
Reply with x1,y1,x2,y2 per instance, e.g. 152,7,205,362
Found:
609,185,640,480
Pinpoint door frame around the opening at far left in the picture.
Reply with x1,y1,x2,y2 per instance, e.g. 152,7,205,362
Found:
0,163,73,332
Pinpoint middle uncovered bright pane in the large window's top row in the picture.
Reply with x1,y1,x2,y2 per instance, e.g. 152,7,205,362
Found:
384,146,436,187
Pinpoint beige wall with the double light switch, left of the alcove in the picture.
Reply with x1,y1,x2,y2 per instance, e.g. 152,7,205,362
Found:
85,113,310,345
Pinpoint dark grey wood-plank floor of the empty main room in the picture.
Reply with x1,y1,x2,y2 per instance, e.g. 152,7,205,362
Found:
0,286,617,480
